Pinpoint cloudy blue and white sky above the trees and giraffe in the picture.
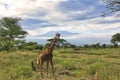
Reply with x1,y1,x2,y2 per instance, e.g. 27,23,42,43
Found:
0,0,120,45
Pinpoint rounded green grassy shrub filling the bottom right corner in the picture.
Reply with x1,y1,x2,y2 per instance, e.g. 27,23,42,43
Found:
87,62,120,80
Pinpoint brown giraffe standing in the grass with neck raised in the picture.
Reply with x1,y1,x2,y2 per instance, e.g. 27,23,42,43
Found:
31,33,60,78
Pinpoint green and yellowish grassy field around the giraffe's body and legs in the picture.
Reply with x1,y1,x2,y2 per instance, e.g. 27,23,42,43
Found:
0,48,120,80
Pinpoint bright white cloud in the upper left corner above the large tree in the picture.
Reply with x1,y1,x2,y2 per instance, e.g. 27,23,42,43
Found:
0,0,65,18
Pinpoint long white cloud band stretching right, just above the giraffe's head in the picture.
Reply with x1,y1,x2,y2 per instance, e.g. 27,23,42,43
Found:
28,17,120,39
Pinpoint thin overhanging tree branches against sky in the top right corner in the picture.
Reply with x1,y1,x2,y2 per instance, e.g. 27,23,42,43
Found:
103,0,120,16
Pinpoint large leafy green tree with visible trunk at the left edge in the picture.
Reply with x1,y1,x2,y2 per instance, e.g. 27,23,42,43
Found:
0,17,27,51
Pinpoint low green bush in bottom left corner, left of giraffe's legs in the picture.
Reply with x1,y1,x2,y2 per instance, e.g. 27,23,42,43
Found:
2,66,33,80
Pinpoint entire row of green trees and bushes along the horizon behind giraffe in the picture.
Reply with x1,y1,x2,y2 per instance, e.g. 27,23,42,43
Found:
0,17,120,51
